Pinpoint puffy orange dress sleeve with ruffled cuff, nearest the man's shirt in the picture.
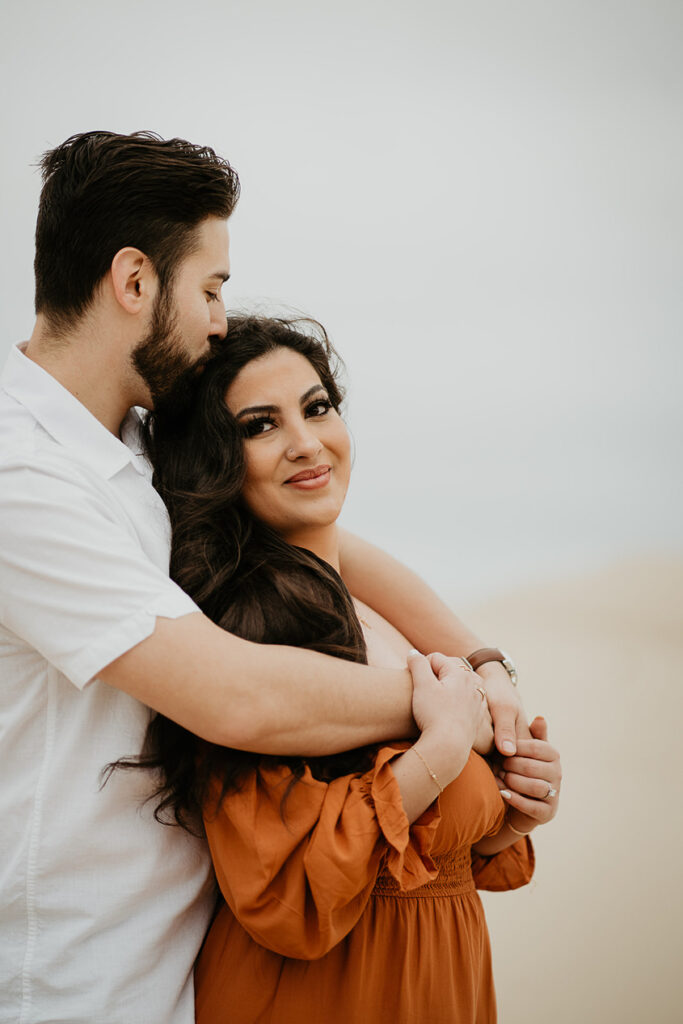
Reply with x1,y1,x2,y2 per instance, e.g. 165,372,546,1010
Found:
205,748,437,959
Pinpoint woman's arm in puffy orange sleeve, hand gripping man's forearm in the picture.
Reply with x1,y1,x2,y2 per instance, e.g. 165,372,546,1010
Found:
205,653,482,959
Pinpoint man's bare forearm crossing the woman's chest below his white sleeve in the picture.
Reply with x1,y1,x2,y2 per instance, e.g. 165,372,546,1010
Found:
99,612,415,756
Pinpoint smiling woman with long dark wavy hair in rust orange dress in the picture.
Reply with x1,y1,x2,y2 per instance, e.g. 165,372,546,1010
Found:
139,317,560,1024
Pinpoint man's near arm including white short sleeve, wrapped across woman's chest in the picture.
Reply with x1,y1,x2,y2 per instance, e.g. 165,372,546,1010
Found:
0,460,415,755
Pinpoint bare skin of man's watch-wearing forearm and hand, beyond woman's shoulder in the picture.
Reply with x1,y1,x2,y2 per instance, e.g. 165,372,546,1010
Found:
339,530,530,756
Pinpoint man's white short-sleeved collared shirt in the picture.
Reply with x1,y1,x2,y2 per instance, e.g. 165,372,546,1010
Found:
0,348,212,1024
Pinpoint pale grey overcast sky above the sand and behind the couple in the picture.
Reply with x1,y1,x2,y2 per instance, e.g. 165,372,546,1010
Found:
0,0,683,600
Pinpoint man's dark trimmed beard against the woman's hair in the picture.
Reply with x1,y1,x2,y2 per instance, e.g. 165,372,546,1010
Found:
131,288,209,411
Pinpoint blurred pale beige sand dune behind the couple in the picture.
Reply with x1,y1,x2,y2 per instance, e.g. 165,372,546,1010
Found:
458,556,683,1024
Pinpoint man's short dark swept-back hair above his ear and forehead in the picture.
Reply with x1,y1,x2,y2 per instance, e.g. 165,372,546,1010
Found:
34,131,240,332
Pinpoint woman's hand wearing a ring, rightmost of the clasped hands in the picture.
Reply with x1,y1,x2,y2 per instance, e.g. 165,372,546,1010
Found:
499,718,562,833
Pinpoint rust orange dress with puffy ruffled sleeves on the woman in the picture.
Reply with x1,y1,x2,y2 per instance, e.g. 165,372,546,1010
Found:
196,743,533,1024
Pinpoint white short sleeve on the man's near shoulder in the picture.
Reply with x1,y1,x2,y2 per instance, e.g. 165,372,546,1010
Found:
0,454,198,688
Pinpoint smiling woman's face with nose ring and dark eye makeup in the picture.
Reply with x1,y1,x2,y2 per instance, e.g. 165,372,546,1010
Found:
225,348,351,543
